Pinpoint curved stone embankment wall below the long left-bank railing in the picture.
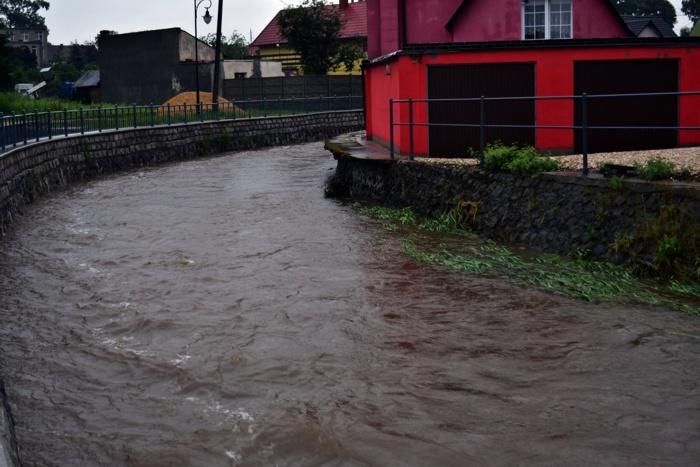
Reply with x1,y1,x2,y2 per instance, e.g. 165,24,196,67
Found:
0,111,364,467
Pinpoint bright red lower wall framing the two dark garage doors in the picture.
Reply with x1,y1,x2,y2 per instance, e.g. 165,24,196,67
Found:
366,45,700,155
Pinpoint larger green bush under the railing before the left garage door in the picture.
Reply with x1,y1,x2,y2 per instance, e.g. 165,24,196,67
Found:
484,145,559,176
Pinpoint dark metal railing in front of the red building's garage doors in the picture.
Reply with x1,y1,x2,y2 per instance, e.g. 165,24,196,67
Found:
389,91,700,175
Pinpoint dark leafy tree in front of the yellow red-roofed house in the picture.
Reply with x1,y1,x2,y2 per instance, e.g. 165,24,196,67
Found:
277,0,363,75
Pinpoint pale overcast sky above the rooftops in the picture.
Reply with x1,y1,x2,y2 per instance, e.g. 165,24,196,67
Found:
46,0,690,44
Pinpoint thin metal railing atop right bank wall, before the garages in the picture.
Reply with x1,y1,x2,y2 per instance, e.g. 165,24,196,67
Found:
389,91,700,175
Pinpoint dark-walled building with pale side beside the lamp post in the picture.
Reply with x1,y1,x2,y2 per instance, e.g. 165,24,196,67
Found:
98,28,215,104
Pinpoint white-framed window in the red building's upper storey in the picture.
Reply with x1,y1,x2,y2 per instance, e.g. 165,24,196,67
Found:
523,0,573,40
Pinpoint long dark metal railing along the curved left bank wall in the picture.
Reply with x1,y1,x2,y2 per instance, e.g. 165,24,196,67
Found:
0,96,364,154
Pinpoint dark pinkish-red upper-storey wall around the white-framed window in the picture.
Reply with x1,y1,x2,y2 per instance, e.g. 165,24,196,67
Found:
367,0,630,58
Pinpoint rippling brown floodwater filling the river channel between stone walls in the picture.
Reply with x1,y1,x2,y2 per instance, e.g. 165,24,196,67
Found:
0,144,700,467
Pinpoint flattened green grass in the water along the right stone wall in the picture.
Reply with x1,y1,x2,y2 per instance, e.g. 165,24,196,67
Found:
354,204,700,316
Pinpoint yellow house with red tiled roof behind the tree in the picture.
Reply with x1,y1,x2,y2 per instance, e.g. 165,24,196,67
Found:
249,0,367,75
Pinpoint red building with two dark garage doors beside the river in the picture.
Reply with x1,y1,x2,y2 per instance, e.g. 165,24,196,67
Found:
365,0,700,156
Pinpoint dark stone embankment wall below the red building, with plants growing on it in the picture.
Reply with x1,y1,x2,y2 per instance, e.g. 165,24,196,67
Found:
329,156,700,280
